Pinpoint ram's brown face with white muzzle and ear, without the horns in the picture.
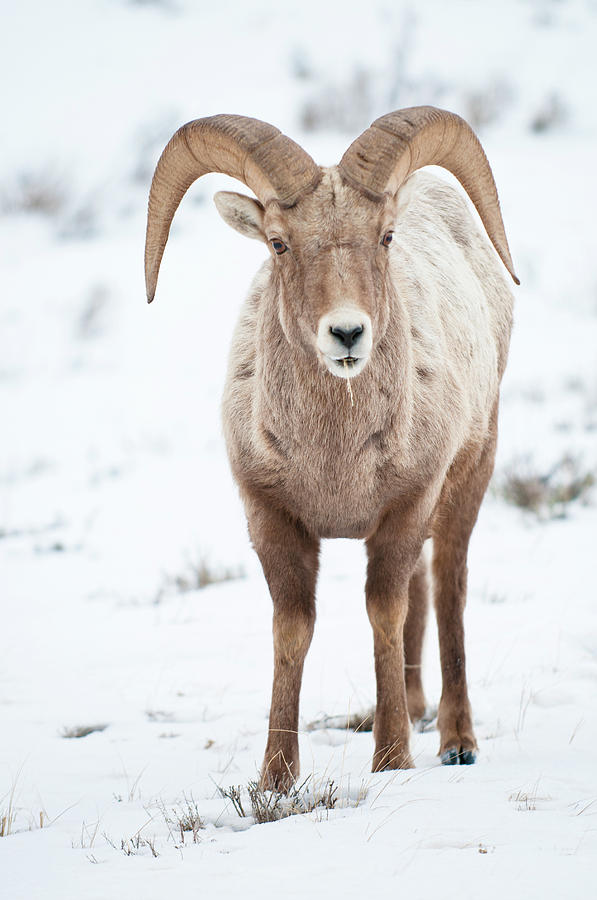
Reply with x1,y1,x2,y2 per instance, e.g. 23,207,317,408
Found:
216,168,396,378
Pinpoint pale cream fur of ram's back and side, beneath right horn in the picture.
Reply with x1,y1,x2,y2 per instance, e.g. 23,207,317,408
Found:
393,172,513,458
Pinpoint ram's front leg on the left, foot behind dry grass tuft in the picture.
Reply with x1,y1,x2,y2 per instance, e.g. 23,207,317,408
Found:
245,488,319,790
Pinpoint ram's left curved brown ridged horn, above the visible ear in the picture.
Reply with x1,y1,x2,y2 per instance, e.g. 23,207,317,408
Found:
145,115,321,303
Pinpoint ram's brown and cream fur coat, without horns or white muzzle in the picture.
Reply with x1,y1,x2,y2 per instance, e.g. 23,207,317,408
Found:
219,169,512,787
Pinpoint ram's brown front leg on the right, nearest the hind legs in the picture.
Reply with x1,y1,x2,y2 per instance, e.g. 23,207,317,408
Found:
366,512,423,772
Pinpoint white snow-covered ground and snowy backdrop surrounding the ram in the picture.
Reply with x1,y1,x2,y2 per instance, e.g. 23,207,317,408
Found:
0,0,597,900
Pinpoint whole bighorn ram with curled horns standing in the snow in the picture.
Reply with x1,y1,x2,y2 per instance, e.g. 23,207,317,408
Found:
145,107,518,788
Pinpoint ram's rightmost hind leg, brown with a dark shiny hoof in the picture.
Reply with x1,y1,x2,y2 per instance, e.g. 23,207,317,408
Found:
433,426,495,765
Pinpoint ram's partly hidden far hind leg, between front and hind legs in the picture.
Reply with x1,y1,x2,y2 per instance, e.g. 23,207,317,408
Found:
404,553,429,723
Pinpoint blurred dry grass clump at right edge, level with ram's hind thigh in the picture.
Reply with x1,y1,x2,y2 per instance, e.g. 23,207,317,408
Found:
497,455,595,519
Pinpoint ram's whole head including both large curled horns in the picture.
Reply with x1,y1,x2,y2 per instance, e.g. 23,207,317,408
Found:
145,106,518,377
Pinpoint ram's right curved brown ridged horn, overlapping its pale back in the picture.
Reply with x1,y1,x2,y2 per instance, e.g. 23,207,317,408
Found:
338,106,520,284
